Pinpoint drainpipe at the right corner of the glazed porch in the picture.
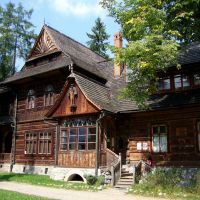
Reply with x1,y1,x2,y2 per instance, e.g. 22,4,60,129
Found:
95,112,105,176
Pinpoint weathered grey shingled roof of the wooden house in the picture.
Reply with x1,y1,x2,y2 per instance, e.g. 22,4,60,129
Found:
1,25,200,112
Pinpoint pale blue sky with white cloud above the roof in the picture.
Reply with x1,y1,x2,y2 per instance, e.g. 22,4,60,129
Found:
0,0,119,69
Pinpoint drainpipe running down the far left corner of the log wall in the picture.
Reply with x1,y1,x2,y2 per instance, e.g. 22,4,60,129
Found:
10,93,18,172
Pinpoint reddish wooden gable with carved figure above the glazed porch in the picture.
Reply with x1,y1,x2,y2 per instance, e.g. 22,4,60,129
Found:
46,80,99,117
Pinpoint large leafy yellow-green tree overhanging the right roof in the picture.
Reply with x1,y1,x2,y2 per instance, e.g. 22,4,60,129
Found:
101,0,200,108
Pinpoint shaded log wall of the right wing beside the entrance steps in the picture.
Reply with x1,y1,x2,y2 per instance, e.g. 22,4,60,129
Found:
117,106,200,166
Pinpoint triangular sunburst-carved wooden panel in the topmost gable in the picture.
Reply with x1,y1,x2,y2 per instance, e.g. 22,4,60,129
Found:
29,27,59,59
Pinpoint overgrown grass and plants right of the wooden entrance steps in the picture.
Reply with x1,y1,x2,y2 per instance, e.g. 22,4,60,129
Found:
128,169,200,200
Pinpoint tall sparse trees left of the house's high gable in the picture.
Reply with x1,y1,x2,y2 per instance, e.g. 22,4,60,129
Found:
0,3,36,79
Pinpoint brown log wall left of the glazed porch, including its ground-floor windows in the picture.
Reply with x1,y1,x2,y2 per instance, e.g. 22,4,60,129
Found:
15,77,65,165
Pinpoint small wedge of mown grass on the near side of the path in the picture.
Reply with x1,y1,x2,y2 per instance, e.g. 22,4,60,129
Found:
0,189,52,200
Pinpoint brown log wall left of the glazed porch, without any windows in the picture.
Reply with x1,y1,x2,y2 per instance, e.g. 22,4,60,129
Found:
16,78,65,165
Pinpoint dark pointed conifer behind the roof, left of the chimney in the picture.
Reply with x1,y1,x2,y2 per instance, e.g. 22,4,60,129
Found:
86,17,110,58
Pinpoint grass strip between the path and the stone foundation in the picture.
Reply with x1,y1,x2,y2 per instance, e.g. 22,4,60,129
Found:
0,173,104,191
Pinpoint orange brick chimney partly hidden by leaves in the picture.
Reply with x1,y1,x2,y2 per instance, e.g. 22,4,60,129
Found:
114,32,123,78
